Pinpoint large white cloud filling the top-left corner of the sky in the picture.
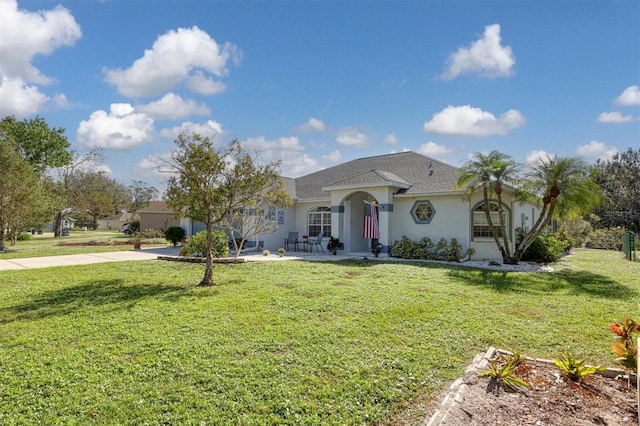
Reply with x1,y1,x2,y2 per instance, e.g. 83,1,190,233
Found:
0,0,82,117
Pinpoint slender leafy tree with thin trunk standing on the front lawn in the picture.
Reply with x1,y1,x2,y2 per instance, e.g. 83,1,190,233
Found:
167,132,292,286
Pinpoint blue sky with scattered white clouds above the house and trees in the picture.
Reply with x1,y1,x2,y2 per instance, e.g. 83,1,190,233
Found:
0,0,640,187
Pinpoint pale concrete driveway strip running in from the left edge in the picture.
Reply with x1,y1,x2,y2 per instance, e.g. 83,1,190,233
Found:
0,247,180,271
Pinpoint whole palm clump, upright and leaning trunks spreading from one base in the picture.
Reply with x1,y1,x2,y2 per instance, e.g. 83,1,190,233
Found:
456,151,600,264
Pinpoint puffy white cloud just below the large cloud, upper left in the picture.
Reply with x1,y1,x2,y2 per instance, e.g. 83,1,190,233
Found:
77,103,153,150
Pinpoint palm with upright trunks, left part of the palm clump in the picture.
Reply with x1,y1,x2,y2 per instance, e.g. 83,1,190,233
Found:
456,151,518,263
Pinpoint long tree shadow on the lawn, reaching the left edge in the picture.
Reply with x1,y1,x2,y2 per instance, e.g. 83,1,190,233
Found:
0,279,193,324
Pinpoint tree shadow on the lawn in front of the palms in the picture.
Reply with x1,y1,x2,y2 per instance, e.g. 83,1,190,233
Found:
447,268,638,300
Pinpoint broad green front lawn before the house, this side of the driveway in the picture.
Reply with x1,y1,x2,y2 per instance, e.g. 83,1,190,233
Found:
0,251,640,425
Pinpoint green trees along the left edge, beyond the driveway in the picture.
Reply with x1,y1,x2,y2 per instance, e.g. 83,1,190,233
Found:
0,116,158,251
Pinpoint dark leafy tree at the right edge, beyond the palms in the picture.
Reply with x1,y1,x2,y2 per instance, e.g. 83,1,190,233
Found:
591,148,640,232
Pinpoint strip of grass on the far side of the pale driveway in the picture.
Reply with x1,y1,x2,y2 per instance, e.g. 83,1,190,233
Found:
0,231,167,259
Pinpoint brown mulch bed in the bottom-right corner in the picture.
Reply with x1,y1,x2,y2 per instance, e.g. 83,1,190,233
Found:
432,352,638,426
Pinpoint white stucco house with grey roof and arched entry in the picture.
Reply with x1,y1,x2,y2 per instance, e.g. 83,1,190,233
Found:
178,151,540,259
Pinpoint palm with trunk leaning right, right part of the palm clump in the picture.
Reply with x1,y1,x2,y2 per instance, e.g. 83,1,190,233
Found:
514,156,600,263
